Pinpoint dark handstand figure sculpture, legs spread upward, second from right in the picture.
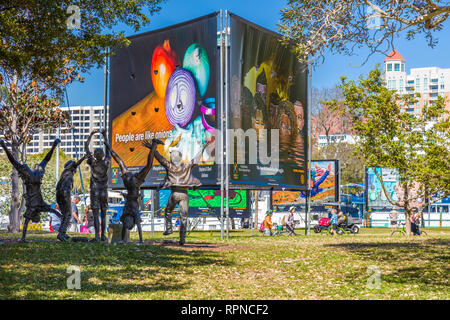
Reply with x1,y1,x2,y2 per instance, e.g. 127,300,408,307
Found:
104,139,164,243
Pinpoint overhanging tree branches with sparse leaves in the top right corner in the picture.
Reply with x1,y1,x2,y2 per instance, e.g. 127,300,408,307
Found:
279,0,450,64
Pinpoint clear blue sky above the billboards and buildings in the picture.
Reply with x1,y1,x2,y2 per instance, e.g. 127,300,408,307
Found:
64,0,450,106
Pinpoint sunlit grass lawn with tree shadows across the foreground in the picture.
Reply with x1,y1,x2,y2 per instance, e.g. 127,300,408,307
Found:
0,228,450,300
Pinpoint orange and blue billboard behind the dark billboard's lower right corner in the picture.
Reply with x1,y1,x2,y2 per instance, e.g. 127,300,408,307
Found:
272,160,340,206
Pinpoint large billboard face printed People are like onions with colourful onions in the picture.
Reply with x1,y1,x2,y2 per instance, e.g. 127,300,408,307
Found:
110,13,220,188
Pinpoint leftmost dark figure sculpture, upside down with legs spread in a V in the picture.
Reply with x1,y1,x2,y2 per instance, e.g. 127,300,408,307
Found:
0,139,61,241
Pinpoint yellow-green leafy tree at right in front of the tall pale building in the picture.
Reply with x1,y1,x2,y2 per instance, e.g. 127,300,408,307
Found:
329,66,450,235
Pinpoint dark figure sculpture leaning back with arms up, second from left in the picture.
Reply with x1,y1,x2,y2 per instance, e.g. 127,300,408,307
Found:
56,155,86,241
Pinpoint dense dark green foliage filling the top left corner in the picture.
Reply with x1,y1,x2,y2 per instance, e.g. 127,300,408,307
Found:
0,0,163,88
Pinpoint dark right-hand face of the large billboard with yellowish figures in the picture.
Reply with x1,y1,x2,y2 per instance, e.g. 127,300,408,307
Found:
228,15,308,190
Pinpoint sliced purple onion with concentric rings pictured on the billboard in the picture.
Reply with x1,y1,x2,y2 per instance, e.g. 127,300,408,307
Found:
165,68,196,127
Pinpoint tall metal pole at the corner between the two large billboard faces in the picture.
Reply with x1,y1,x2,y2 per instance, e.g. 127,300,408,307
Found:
219,10,225,240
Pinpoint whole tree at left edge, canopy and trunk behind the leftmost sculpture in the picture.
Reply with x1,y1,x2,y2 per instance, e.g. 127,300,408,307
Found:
0,0,163,233
